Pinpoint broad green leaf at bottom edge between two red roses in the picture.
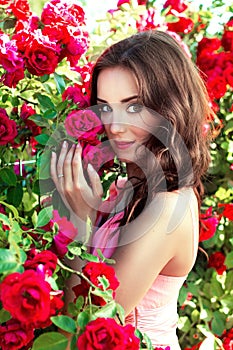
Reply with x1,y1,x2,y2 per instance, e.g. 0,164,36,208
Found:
32,332,68,350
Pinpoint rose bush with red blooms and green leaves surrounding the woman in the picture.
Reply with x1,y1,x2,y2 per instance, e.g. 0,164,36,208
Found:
0,0,233,350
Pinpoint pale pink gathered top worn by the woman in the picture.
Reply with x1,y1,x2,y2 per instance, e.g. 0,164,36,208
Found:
92,182,199,350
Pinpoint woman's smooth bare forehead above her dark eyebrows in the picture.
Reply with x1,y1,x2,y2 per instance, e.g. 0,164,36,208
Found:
97,67,139,103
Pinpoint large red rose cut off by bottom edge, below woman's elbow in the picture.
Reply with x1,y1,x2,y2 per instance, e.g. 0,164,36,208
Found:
77,318,140,350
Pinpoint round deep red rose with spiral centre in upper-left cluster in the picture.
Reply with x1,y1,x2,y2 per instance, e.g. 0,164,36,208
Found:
24,31,60,76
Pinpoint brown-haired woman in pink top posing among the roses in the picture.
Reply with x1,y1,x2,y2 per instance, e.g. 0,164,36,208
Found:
51,30,212,350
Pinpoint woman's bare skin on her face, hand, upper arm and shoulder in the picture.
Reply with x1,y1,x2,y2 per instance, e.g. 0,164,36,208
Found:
51,67,198,315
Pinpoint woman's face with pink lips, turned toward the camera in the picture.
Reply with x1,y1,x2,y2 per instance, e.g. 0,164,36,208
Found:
97,67,158,162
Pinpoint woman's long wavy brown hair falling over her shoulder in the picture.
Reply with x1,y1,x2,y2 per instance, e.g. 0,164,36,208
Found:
91,30,213,224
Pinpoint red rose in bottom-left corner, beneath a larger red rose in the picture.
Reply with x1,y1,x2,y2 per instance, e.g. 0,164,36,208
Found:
0,319,34,350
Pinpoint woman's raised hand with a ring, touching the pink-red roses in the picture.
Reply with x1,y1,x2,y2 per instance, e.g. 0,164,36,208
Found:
50,141,103,222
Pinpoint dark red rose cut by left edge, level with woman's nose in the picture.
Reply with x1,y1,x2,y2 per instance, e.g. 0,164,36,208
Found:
0,108,17,146
